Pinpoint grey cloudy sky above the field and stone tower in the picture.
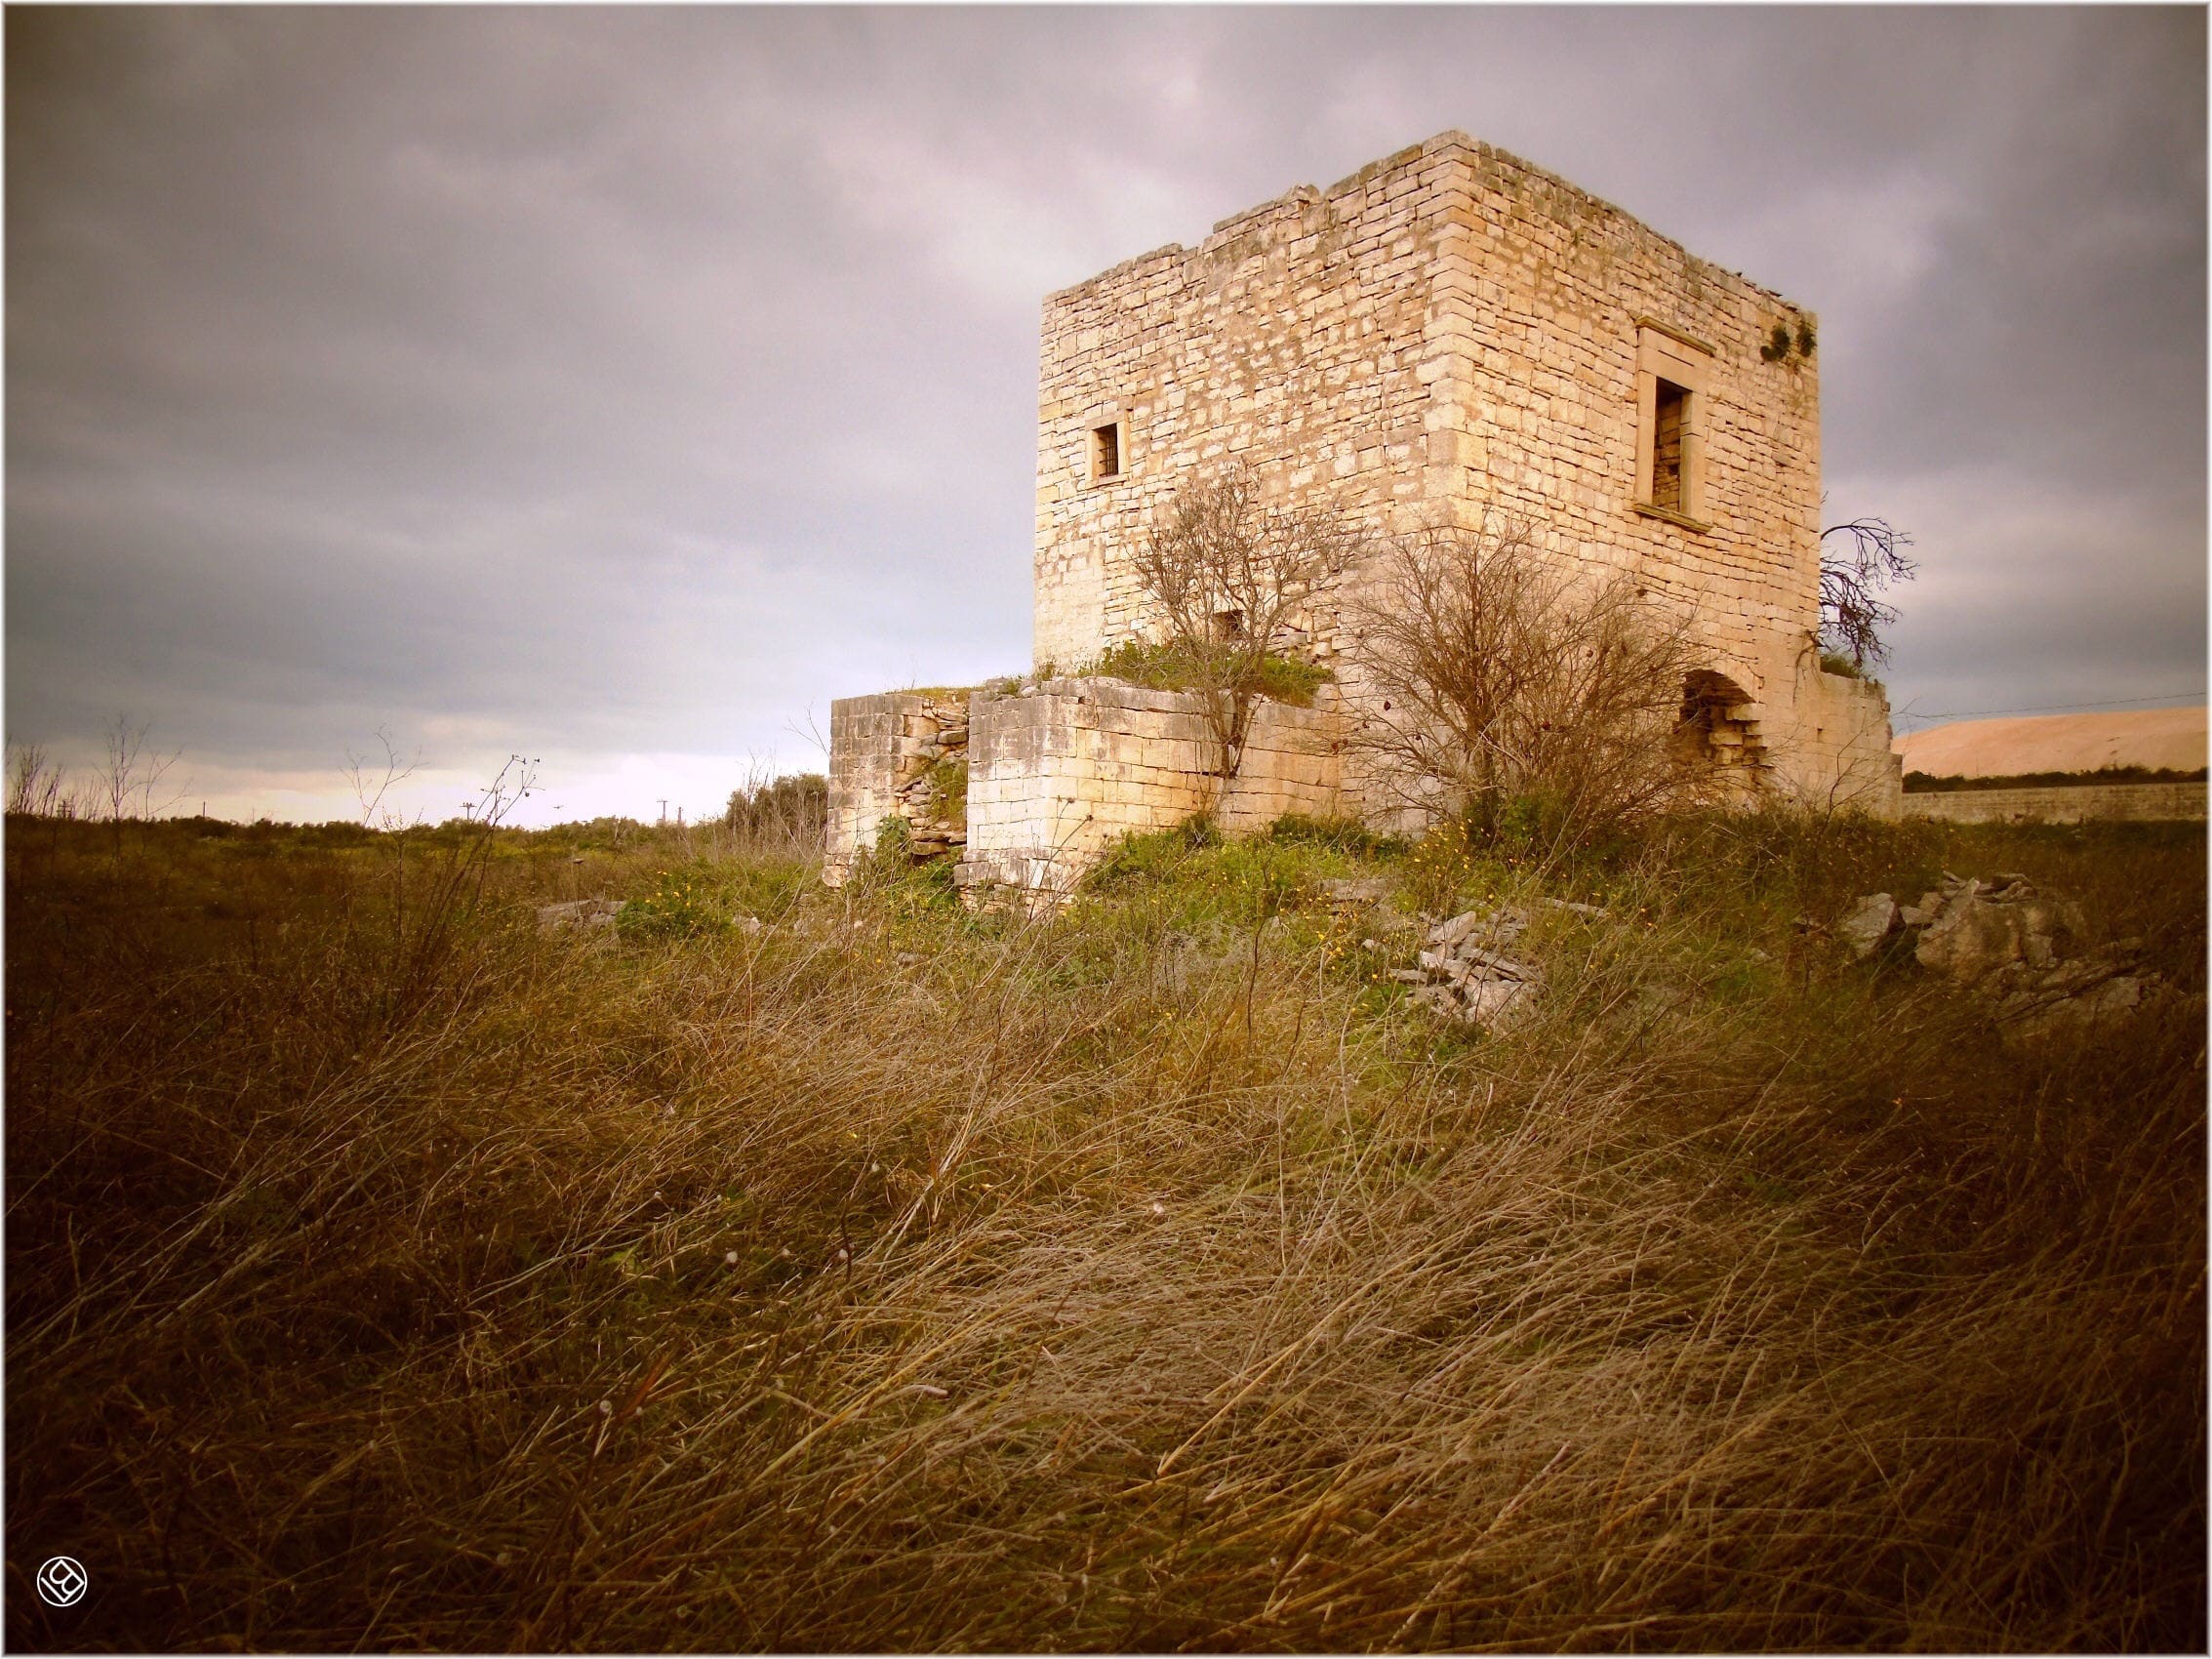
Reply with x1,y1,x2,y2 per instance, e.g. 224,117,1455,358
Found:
5,7,2205,819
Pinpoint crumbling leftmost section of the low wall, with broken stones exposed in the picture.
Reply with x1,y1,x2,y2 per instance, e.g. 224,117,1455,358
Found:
823,690,969,885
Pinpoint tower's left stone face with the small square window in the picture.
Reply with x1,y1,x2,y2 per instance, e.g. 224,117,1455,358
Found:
1035,135,1458,668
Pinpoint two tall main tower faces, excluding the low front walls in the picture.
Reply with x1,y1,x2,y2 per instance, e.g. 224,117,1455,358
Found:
1035,133,1849,818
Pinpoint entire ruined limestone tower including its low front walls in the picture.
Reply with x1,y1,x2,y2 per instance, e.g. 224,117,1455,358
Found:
829,133,1898,887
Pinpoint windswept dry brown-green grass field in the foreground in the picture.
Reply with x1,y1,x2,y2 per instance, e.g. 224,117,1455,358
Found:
7,816,2205,1652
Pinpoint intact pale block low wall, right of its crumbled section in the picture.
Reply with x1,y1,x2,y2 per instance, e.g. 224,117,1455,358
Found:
958,679,1343,891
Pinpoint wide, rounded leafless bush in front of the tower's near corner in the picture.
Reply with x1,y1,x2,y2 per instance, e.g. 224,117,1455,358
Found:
1353,515,1704,836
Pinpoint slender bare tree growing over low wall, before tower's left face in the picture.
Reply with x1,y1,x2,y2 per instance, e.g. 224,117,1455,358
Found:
1135,463,1365,779
